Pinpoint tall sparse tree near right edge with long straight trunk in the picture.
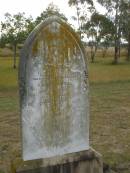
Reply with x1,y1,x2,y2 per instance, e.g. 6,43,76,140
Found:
98,0,130,64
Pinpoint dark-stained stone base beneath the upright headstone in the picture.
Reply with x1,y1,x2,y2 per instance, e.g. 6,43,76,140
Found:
16,149,103,173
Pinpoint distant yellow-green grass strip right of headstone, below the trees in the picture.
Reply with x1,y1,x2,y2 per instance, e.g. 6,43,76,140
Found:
89,58,130,83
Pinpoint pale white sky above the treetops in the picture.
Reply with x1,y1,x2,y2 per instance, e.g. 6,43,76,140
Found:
0,0,104,27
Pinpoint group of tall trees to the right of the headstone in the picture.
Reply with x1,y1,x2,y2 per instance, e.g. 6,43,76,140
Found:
69,0,130,64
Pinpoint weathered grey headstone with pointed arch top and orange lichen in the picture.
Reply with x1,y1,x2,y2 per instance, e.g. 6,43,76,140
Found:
19,16,89,160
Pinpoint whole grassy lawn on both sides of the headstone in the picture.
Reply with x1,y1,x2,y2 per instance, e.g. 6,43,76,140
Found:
0,57,130,173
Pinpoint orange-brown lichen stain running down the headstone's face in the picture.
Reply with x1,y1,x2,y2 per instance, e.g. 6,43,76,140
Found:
32,23,80,146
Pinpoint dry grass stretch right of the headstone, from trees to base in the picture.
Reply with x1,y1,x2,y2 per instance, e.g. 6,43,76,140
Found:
89,58,130,171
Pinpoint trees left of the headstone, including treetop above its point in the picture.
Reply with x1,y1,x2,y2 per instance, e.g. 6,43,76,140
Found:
0,3,67,69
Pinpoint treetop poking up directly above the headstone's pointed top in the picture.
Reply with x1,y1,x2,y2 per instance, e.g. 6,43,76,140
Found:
35,3,67,25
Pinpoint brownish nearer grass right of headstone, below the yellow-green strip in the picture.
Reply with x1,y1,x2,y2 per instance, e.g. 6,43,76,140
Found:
90,81,130,165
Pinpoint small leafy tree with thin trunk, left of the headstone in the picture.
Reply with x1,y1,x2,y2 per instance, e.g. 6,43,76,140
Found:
1,13,34,68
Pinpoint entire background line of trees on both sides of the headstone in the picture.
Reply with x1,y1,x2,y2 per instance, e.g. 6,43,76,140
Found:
0,0,130,68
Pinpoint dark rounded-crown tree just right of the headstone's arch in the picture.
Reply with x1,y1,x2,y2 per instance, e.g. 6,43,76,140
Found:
83,12,114,62
